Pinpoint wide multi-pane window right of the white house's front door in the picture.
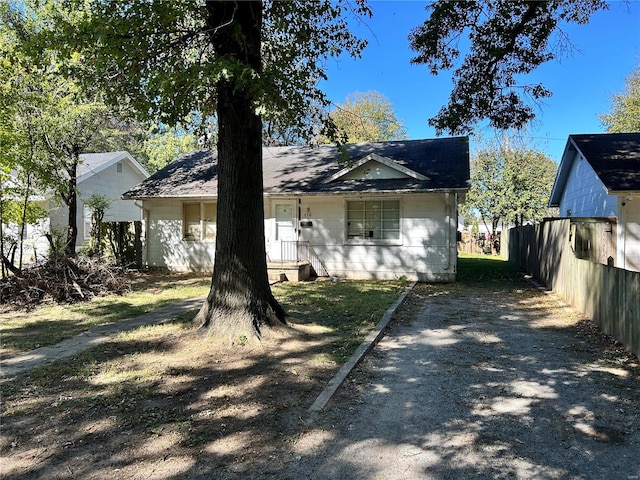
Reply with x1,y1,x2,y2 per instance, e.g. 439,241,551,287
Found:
347,200,400,243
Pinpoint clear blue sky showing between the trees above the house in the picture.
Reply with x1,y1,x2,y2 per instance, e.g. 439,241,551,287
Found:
322,0,640,162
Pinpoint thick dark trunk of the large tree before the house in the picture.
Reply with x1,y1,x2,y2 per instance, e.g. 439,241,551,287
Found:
196,1,285,338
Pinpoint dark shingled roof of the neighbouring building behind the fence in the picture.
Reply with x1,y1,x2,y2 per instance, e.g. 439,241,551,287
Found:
549,133,640,206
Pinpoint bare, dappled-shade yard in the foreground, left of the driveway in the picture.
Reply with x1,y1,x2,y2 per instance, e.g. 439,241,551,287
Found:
0,316,350,479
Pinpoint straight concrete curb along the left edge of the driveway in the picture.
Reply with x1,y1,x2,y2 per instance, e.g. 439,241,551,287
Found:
309,282,417,412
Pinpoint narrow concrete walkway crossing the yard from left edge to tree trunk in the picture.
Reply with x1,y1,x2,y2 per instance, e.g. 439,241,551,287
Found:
0,296,206,383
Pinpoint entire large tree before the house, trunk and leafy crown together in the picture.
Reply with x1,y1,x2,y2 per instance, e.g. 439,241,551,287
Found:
25,0,370,337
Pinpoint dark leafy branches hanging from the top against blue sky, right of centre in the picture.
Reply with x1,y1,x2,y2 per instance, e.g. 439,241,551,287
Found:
409,0,608,134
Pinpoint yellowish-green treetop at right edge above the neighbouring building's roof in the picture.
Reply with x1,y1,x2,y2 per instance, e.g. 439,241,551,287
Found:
600,65,640,133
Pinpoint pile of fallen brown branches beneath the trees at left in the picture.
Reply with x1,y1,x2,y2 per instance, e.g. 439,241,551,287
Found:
0,257,131,309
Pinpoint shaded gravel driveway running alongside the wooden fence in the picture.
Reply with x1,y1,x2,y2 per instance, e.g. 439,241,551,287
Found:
288,283,640,480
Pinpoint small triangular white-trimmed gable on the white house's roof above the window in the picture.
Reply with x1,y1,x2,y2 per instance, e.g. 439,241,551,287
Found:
322,153,427,183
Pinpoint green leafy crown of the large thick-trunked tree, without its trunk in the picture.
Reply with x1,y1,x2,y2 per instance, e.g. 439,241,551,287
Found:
51,0,370,141
